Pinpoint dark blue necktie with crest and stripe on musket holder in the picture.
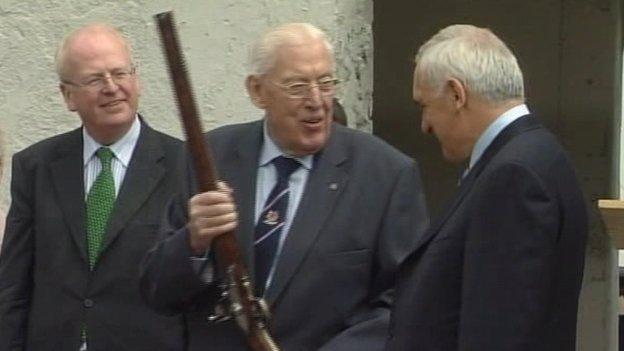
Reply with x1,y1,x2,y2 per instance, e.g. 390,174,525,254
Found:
254,156,301,296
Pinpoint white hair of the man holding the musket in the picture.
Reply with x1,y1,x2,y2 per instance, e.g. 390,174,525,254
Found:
249,23,334,75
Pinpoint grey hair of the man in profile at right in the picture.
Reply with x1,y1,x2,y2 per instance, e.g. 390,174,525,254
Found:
415,24,524,103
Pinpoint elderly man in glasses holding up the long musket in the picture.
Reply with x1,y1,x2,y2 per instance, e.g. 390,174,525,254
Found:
142,23,427,351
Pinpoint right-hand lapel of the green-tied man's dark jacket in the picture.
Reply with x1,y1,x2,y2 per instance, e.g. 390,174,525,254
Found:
102,122,165,253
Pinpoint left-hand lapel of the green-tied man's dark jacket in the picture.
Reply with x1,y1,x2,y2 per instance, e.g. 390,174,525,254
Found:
50,128,87,264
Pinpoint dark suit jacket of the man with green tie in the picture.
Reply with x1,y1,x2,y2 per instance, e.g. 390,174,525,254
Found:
0,123,184,351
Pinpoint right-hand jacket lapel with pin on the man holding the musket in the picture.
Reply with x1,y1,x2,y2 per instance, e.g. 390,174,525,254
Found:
266,128,348,304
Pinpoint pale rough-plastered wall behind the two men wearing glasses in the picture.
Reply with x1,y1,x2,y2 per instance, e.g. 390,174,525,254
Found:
0,0,373,239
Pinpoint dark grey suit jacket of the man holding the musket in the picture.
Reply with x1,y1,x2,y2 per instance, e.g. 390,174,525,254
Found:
142,121,427,350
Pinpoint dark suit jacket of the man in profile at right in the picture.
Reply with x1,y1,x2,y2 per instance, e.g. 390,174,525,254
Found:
386,116,587,351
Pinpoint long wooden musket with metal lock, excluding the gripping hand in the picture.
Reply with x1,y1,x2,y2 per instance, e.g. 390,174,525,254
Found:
155,12,280,351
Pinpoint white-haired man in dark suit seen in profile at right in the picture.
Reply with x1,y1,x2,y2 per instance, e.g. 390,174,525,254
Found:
386,25,587,351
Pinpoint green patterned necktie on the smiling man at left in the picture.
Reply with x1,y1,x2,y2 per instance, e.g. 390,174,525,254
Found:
87,147,115,269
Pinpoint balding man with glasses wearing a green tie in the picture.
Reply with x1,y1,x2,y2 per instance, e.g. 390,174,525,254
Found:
0,25,184,351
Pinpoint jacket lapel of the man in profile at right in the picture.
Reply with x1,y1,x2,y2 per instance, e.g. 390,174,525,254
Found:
414,115,541,252
